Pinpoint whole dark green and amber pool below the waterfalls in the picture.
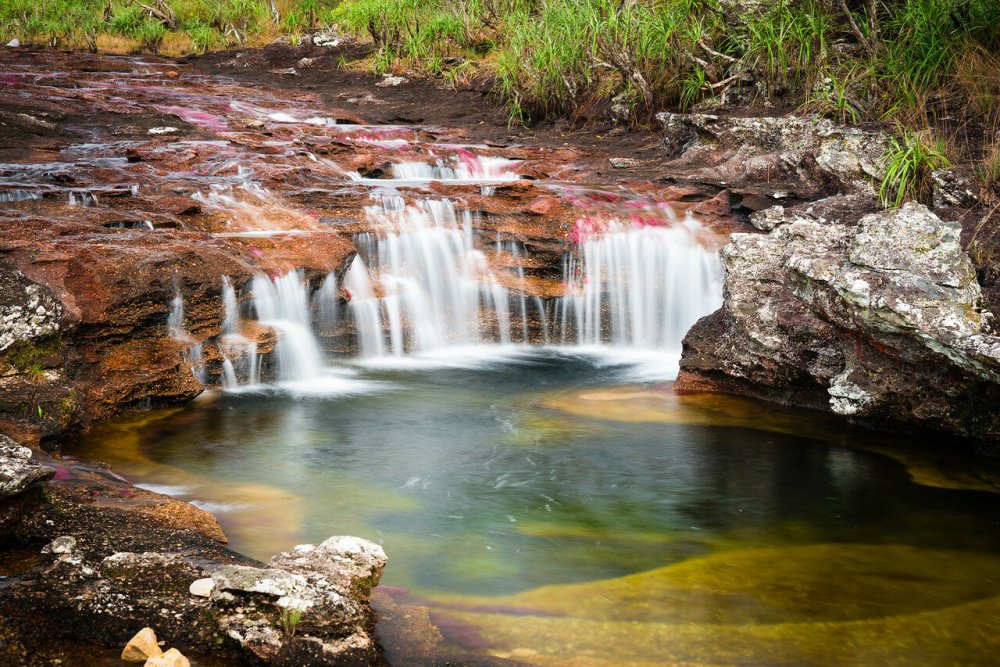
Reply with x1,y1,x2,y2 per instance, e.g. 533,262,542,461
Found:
68,350,1000,665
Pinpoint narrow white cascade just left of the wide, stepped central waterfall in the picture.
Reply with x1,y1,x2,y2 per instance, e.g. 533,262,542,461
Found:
253,271,326,381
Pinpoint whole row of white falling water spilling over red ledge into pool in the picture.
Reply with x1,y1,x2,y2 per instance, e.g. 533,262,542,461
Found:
171,156,722,390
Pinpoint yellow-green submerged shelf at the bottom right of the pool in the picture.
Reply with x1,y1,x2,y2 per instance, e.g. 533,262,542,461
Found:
431,544,1000,666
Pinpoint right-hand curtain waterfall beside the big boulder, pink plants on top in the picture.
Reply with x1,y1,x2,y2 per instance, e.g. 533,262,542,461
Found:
558,218,722,354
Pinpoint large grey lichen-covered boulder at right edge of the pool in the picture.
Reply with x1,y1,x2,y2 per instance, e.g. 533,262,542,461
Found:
676,203,1000,444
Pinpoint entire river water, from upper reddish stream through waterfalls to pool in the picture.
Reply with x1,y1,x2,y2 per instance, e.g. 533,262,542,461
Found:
0,49,1000,667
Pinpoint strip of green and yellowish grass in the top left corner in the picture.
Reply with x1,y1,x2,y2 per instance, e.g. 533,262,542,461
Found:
0,0,339,55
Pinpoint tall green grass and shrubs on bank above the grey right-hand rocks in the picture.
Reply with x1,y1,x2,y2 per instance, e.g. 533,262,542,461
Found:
332,0,1000,203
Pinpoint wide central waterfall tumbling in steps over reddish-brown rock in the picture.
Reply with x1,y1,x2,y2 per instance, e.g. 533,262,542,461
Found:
344,196,510,357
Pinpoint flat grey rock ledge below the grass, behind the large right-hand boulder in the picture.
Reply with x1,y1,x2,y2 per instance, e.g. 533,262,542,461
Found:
657,113,888,200
